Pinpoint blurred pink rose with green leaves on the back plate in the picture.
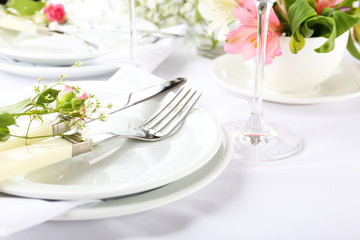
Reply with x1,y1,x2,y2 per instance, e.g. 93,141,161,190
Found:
0,0,66,25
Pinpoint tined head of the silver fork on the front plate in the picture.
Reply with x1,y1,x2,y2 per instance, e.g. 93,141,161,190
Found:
151,89,201,136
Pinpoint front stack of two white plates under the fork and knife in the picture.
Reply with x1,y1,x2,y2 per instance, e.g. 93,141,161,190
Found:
0,82,232,220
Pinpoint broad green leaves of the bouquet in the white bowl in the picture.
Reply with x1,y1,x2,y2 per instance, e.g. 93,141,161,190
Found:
274,0,360,54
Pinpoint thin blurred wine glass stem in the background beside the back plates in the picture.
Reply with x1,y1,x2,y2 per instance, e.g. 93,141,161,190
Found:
129,0,138,67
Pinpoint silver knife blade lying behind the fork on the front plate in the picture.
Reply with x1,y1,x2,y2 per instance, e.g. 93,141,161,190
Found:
52,78,186,135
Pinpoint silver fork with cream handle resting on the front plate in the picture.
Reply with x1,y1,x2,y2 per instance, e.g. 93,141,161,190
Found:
0,89,201,182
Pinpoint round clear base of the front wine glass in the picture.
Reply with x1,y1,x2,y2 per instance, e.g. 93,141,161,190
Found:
226,121,303,161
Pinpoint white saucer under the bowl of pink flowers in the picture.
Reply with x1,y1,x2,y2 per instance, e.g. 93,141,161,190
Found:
210,54,360,104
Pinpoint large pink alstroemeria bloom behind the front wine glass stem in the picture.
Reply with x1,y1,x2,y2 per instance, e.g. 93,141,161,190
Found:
224,0,282,65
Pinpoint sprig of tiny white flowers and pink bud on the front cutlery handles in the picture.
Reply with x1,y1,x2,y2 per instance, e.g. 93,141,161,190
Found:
0,62,112,141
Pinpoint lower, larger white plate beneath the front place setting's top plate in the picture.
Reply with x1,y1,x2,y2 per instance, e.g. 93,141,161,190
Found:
54,128,233,221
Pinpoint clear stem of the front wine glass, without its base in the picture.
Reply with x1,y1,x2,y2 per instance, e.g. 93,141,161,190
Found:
246,0,273,135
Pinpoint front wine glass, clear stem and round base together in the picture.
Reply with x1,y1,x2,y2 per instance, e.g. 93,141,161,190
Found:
228,0,302,161
